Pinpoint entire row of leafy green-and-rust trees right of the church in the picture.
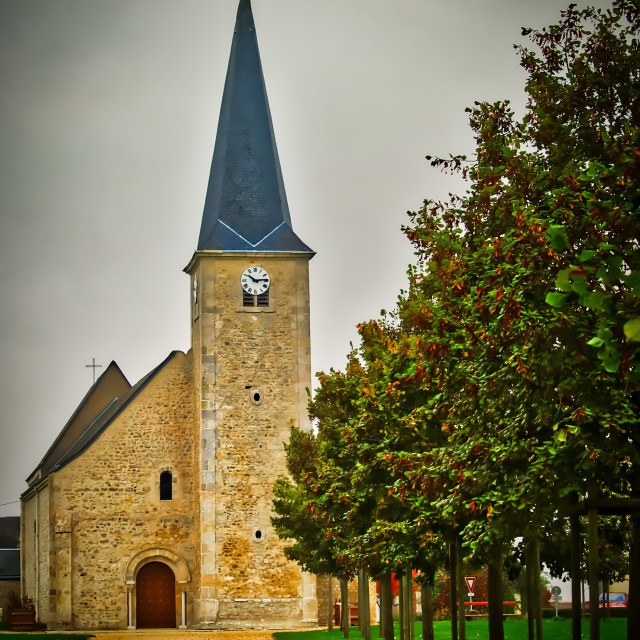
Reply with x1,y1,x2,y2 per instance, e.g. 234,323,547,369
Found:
274,0,640,640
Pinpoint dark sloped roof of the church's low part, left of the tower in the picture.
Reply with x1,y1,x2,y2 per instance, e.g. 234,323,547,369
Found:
25,351,178,484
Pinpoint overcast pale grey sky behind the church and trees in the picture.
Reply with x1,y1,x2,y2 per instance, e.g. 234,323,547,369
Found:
0,0,608,516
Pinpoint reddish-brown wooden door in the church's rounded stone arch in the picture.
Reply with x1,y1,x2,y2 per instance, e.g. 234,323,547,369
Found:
136,562,176,629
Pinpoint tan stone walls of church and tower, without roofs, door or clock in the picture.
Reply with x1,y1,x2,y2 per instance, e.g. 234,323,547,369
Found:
22,249,317,629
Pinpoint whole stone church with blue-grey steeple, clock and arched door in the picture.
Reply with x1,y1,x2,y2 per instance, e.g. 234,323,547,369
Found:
20,0,318,629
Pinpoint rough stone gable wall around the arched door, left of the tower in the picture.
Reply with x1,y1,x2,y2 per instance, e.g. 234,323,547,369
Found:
50,353,199,629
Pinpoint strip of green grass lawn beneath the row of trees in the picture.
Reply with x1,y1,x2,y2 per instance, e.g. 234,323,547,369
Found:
273,618,627,640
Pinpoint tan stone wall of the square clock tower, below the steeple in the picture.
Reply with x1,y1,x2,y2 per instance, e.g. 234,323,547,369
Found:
190,254,317,628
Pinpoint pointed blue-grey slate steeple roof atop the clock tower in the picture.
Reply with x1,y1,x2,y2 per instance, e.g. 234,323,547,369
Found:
198,0,313,253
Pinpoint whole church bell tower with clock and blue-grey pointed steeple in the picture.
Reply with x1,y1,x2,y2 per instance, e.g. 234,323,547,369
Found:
185,0,317,629
